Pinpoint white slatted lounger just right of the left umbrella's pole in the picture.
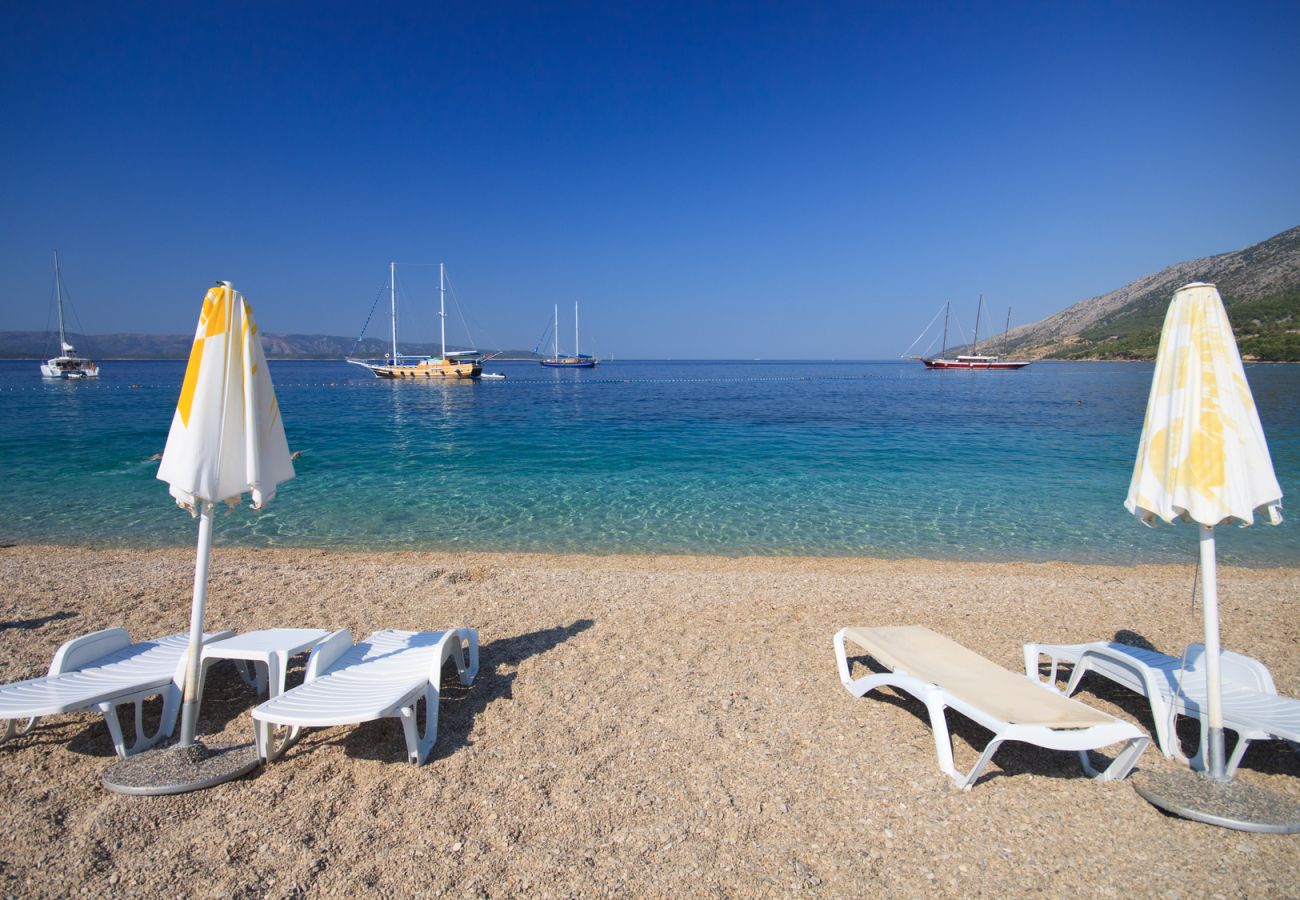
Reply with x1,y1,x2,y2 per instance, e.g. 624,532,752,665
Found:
252,628,478,765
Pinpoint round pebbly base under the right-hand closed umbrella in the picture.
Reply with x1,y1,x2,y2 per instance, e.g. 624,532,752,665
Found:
1130,769,1300,835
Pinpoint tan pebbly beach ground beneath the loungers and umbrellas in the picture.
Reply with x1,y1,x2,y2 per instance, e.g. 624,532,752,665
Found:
0,546,1300,897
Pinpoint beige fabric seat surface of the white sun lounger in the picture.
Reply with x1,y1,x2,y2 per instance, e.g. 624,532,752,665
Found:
845,626,1115,728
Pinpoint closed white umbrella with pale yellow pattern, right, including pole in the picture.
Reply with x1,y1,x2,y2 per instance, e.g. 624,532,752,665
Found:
1125,284,1282,780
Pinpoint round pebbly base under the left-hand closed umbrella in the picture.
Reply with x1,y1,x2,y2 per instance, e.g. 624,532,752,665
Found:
103,741,259,796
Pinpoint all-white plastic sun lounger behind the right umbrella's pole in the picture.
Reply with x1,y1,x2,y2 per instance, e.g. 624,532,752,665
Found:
1024,641,1300,775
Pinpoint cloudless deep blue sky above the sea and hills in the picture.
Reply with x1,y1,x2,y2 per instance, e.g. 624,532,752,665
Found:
0,0,1300,359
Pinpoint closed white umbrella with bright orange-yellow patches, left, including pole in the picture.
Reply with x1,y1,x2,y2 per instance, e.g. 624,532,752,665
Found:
159,281,294,747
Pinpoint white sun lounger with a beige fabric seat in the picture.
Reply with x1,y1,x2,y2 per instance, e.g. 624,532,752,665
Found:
835,626,1151,789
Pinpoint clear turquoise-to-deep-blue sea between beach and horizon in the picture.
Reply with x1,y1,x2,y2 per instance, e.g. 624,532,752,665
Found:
0,360,1300,564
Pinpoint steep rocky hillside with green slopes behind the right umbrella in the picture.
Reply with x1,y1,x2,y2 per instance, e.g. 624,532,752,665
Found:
984,226,1300,362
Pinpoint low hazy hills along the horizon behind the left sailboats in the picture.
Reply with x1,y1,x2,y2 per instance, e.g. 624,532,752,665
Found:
0,332,541,359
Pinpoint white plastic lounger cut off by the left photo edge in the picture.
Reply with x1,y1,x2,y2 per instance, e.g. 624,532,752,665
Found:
0,628,234,757
